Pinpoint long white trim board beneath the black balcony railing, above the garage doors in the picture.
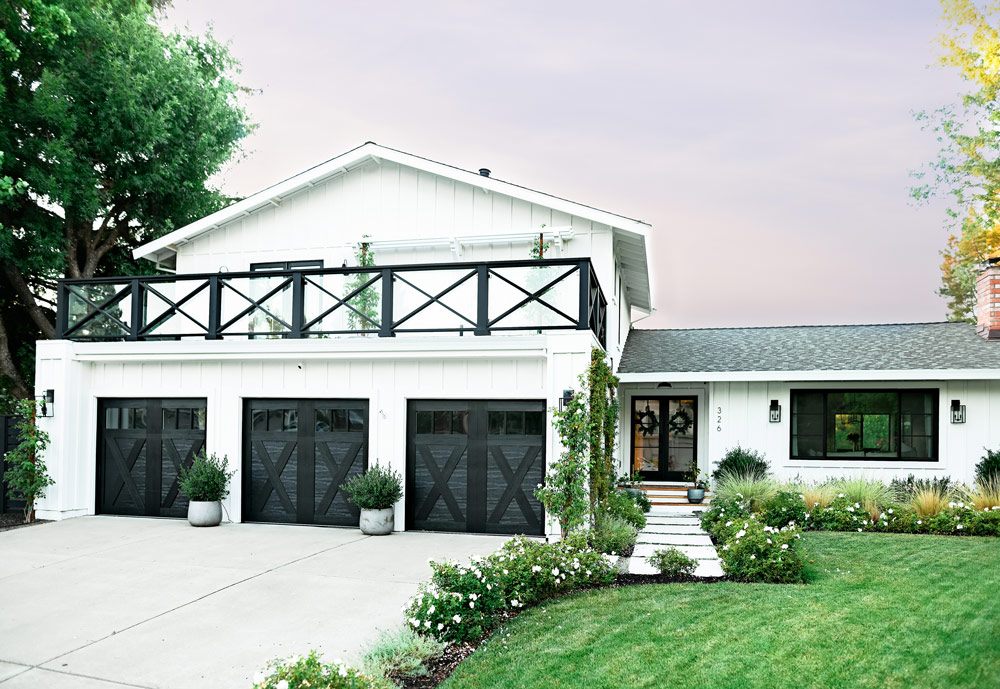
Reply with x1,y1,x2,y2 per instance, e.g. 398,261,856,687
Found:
71,333,559,361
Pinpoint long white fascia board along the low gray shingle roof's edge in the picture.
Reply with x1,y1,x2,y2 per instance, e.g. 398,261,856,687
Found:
618,368,1000,383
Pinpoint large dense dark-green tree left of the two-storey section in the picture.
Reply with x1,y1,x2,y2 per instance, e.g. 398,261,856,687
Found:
0,0,251,397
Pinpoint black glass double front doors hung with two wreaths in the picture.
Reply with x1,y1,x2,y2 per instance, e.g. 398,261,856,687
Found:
631,397,698,481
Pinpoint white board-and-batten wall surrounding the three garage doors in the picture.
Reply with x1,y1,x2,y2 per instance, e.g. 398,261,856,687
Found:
37,332,593,529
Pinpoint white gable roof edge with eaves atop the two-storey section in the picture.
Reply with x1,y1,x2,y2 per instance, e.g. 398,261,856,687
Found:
132,141,651,311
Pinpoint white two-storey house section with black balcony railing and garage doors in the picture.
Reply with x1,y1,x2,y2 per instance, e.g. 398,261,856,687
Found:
36,143,650,534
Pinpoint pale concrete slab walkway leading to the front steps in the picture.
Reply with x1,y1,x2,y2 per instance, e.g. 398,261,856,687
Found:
628,507,723,577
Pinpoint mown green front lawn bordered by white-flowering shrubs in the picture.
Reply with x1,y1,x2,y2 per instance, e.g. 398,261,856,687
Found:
442,533,1000,689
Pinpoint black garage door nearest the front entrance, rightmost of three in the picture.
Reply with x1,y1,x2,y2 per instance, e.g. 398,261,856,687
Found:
406,400,545,534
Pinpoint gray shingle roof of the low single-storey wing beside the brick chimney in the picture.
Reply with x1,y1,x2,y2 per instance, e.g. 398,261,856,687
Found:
619,323,1000,373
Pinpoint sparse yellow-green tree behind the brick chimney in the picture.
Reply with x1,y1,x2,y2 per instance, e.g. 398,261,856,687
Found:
913,0,1000,320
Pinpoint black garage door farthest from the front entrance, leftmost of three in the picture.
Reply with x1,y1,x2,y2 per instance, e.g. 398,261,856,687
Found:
97,399,206,517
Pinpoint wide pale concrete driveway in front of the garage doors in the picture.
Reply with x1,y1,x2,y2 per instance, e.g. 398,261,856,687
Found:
0,517,504,689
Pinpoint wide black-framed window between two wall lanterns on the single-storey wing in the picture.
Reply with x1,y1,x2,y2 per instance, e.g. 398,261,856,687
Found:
791,390,939,462
